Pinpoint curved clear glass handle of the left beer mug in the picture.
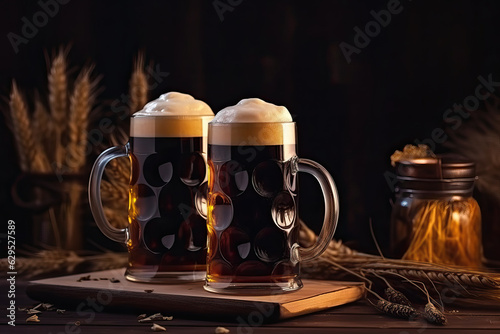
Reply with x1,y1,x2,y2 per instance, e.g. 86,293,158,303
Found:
88,144,129,243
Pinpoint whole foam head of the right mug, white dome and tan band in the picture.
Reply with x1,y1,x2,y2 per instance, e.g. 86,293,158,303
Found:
208,98,295,146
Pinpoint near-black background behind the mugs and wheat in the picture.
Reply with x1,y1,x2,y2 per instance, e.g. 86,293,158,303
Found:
0,0,500,251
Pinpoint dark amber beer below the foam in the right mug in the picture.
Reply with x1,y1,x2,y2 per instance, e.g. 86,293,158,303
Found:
206,144,299,283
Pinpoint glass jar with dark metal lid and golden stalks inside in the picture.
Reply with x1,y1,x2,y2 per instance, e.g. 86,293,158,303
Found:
391,156,482,268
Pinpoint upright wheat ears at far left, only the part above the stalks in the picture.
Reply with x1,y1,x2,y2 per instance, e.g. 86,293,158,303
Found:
9,49,97,174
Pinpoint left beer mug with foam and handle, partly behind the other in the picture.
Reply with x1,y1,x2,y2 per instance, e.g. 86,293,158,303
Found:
88,92,213,282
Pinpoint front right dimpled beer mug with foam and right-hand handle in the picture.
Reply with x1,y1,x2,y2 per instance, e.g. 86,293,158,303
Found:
204,99,339,294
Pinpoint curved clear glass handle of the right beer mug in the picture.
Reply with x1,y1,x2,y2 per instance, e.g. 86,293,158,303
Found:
291,156,339,263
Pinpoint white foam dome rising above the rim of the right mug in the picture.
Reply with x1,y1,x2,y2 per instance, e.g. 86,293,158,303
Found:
212,98,292,123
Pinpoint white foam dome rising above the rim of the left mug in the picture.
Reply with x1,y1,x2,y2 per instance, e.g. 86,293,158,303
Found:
134,92,214,116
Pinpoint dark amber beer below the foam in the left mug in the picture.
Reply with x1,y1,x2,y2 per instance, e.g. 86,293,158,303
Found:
127,137,207,280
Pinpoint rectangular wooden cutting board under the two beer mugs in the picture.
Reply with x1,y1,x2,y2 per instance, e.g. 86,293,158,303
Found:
26,269,365,322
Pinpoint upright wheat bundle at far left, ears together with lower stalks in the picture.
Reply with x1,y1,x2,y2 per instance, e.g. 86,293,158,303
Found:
5,49,98,249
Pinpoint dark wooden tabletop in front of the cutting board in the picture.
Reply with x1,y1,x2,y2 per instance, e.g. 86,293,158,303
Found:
0,278,500,334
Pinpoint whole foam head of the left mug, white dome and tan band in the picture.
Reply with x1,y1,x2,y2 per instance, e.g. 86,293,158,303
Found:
130,92,214,137
